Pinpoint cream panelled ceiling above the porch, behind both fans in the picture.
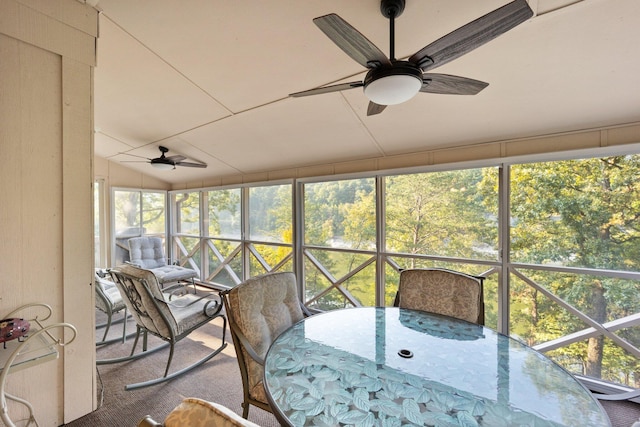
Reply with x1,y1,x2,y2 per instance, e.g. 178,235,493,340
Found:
92,0,640,183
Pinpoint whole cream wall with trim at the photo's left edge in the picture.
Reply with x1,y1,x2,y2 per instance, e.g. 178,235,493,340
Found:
0,0,98,426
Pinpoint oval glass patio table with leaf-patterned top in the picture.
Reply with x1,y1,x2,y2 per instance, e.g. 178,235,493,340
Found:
264,307,611,427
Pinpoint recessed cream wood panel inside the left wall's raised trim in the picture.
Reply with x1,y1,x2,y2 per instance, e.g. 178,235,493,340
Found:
0,34,63,425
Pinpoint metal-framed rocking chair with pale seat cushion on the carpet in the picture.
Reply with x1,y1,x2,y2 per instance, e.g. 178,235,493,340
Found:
102,264,227,390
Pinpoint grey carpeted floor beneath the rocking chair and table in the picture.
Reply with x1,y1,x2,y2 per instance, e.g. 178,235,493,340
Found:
65,310,640,427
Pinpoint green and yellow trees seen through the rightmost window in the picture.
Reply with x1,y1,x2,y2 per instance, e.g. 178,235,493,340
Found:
511,156,640,377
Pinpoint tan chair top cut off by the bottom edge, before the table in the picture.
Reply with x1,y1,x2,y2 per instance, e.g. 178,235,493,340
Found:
164,397,258,427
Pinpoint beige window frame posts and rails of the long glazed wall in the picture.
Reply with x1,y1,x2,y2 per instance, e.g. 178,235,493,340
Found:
156,144,640,390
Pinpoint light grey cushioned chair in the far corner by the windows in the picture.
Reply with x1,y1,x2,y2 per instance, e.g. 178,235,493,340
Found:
127,236,198,287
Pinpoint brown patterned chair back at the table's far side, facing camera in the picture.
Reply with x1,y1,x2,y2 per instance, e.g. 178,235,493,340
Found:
393,268,484,325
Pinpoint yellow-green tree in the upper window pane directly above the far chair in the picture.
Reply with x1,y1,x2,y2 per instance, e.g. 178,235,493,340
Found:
385,169,498,260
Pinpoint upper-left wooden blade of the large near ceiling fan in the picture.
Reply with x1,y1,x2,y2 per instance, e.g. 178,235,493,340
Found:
313,13,391,68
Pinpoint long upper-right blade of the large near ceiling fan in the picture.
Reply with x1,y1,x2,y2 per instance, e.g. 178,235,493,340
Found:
409,0,533,71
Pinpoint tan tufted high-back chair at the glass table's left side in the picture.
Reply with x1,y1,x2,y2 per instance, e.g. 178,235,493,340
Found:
221,272,310,418
